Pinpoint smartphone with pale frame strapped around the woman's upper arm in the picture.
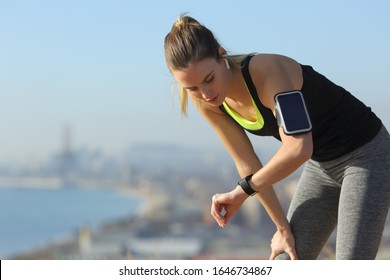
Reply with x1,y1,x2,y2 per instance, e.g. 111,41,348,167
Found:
275,91,312,135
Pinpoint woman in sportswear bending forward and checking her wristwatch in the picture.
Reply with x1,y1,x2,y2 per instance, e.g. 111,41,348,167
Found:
164,15,390,259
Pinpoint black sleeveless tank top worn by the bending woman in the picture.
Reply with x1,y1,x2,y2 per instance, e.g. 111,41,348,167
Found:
220,55,382,161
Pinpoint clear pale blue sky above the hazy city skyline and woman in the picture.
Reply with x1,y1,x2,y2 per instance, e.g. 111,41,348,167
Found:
0,0,390,162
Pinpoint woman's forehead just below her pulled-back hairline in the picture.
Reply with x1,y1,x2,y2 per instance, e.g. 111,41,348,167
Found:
171,58,217,87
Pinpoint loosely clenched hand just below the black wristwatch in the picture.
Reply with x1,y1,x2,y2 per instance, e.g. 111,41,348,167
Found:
211,186,248,227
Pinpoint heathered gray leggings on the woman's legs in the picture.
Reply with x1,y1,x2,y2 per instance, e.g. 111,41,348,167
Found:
277,127,390,260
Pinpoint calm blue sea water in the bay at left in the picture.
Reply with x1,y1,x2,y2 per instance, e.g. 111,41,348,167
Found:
0,186,142,258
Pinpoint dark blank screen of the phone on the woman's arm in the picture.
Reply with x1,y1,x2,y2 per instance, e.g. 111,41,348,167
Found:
277,92,311,132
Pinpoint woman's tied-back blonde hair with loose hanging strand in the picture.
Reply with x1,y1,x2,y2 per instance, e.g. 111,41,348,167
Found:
164,14,247,116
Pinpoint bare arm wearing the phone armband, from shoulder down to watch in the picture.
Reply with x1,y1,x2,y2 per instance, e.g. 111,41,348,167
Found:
250,55,313,192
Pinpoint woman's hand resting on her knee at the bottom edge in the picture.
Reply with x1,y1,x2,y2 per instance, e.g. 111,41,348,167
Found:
269,225,298,260
